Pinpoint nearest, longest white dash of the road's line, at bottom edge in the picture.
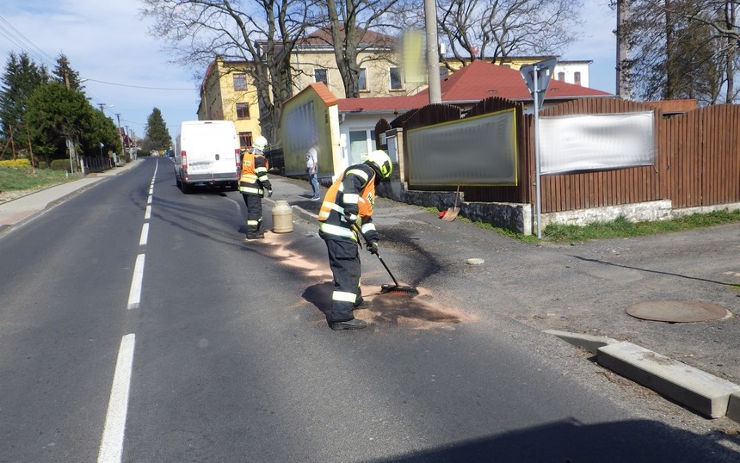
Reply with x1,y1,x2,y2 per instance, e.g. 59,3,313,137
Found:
98,333,136,463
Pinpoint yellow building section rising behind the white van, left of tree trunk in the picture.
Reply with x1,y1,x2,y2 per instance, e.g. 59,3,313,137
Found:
198,58,262,148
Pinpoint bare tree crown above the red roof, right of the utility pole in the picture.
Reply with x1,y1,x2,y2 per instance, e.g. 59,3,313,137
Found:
437,0,581,69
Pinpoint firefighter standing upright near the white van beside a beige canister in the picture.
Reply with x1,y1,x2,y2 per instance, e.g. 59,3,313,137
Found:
239,136,272,240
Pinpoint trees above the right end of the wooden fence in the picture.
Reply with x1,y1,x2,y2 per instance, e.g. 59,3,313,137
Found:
625,0,740,104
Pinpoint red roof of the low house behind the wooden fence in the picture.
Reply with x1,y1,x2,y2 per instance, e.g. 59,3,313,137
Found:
339,60,611,111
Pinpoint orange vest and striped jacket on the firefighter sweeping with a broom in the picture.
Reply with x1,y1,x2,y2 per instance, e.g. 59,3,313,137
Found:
319,164,377,241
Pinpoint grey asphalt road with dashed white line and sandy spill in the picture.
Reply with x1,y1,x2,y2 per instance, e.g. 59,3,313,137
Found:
0,159,738,462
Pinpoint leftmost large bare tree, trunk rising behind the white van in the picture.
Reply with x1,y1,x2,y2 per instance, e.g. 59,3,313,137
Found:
142,0,313,143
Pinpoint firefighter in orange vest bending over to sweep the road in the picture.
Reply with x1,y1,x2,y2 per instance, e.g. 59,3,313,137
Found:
319,150,393,330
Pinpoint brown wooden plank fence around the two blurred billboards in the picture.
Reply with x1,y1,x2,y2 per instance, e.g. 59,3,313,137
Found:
391,98,740,213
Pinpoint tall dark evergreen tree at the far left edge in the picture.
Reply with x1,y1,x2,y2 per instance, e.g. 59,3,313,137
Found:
0,52,49,136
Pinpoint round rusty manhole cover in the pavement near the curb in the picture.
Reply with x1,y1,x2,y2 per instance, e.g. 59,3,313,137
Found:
627,301,730,323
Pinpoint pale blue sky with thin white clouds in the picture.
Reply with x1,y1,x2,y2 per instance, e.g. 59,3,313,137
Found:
0,0,616,138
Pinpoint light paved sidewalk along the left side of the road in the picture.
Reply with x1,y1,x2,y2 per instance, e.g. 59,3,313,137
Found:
0,160,141,232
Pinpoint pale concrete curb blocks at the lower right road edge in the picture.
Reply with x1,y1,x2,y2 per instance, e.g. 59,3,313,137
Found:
545,330,740,423
